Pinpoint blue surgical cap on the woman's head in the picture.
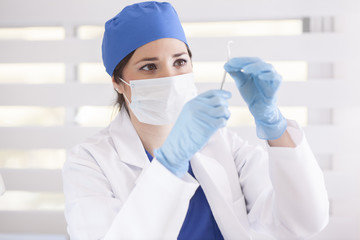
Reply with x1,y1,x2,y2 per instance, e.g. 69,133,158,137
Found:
102,1,187,76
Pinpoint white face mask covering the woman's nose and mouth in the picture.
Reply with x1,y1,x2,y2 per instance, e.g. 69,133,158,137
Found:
120,73,197,125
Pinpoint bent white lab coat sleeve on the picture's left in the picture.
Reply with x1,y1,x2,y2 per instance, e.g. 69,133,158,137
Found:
63,145,198,240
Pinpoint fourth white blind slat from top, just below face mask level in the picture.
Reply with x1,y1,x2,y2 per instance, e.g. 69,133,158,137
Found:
0,125,360,154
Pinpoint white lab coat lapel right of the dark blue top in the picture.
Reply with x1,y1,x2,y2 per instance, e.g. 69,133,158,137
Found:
191,153,251,239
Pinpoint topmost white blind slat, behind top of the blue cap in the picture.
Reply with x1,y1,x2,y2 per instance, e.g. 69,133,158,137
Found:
0,0,359,25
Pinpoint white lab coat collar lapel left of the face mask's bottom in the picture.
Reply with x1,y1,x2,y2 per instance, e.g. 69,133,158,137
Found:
109,107,149,168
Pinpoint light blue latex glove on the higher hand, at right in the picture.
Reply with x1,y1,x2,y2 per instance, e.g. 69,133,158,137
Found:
224,58,287,140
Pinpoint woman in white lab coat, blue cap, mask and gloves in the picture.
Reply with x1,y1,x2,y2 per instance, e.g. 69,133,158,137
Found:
63,2,328,239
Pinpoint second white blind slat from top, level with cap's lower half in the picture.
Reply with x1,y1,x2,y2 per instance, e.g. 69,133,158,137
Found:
0,33,357,63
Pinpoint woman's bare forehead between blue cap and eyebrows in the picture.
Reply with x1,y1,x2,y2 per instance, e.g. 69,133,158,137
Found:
133,38,187,58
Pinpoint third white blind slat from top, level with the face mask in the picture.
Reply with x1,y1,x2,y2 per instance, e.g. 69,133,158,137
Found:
0,81,360,108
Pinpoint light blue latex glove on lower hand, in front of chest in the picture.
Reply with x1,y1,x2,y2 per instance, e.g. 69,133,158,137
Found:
154,90,231,177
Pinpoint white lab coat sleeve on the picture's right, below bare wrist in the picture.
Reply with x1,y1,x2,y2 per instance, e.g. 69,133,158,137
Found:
236,121,329,239
